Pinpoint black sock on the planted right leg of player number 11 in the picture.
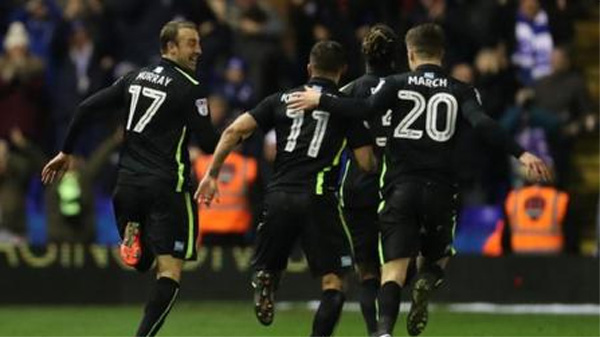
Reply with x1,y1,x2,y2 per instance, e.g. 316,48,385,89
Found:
311,289,346,336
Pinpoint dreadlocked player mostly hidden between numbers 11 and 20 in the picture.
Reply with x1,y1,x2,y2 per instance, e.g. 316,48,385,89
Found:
340,24,398,336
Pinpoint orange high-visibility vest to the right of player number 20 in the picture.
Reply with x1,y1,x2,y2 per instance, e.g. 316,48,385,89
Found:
504,185,569,254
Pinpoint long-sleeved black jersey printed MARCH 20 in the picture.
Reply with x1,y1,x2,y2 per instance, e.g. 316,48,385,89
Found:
319,64,523,187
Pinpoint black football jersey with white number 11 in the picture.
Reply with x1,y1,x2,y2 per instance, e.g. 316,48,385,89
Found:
250,78,371,194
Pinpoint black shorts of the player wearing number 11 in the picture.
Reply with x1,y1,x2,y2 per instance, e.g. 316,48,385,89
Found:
252,191,353,276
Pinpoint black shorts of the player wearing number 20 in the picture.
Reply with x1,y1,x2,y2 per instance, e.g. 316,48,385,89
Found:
379,178,458,263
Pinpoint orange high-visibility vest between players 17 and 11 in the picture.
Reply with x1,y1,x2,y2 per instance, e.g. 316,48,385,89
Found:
194,152,257,235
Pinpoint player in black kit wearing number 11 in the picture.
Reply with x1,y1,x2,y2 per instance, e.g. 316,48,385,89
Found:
196,41,376,336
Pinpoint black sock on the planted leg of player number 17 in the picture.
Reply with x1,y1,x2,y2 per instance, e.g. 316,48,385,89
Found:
136,277,179,336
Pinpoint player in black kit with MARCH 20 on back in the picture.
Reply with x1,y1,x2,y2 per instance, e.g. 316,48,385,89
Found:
288,24,550,336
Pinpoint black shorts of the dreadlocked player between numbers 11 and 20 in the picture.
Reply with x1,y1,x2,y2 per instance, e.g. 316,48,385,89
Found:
344,205,379,266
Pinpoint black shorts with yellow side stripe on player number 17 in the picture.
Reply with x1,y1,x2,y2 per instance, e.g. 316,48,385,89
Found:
113,183,198,260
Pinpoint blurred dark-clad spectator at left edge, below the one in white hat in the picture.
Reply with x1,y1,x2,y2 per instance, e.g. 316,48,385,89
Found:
0,128,45,242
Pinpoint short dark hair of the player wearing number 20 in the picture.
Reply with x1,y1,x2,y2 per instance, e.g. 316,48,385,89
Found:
405,23,444,59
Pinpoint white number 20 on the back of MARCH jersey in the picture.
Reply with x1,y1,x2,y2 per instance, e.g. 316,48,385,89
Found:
394,90,458,142
